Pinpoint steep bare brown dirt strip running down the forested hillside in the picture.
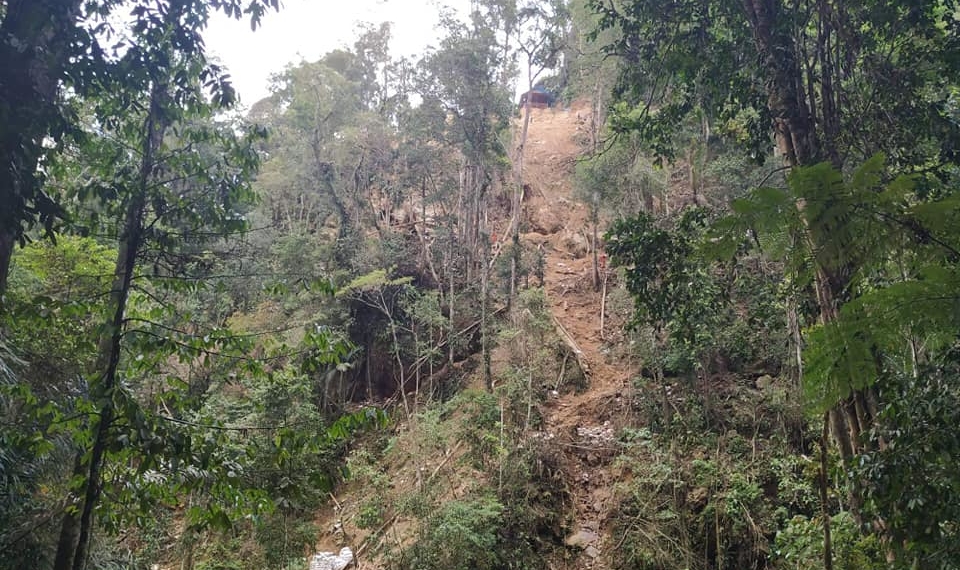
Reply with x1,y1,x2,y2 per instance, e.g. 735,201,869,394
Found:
523,101,633,568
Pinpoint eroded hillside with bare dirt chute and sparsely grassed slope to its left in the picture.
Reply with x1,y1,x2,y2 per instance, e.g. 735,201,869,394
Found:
304,104,636,568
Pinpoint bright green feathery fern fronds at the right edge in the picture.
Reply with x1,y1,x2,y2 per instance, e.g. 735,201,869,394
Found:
709,154,960,411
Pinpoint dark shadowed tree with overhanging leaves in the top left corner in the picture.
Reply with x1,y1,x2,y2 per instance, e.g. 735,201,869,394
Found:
0,0,279,296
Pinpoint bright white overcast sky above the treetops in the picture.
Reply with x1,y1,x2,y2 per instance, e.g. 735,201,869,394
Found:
204,0,468,106
